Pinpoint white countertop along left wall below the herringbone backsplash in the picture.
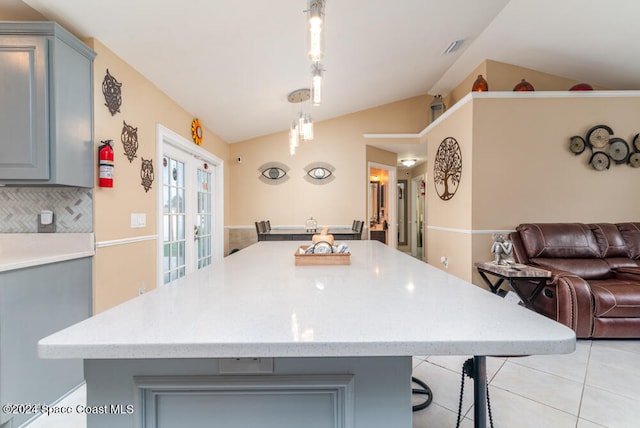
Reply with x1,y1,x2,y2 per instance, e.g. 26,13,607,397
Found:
0,233,95,272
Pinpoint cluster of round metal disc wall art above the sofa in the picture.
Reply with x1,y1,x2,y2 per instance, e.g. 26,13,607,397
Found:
569,125,640,171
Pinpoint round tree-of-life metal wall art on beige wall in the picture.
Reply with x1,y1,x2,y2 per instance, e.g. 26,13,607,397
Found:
433,137,462,201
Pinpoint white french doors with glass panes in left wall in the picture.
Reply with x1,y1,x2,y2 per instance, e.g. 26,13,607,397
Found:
158,128,223,284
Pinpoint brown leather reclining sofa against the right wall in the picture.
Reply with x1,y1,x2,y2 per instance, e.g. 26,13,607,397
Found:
509,223,640,338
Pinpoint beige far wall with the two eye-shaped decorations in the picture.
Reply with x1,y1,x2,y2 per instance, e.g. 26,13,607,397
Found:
227,96,429,248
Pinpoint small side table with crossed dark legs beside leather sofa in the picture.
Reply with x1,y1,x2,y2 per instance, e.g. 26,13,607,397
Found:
475,262,551,307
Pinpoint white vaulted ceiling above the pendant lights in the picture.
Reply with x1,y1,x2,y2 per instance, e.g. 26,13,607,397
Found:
17,0,640,150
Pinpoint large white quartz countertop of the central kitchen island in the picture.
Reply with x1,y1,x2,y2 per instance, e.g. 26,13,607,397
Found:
38,241,575,359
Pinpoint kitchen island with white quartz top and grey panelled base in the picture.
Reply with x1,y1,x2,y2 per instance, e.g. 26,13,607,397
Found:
39,241,575,428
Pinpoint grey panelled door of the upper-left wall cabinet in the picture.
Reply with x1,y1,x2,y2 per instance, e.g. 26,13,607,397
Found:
0,36,50,180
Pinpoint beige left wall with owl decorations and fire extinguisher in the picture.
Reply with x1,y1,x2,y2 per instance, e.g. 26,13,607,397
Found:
87,40,230,313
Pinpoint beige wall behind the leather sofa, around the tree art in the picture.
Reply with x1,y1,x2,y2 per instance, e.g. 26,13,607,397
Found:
427,93,640,285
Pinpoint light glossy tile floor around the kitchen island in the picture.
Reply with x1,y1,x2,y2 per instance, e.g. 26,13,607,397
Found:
28,340,640,428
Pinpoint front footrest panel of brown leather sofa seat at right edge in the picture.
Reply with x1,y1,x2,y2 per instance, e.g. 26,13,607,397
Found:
589,279,640,318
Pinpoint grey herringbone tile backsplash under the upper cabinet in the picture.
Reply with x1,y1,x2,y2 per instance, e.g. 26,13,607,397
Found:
0,187,93,233
